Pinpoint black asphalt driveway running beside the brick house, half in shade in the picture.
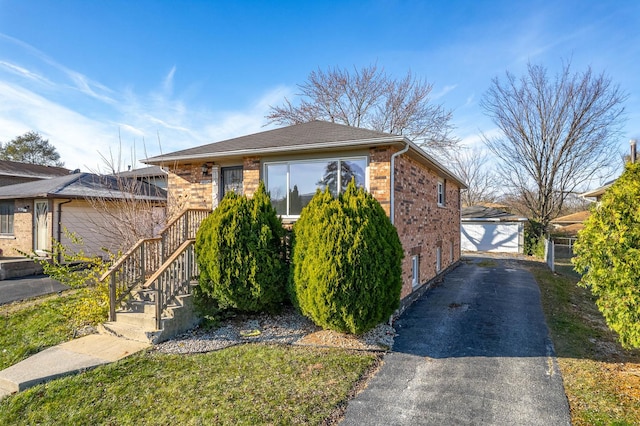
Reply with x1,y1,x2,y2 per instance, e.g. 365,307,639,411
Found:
341,256,571,426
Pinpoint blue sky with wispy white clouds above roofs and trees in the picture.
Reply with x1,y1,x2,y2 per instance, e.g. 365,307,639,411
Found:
0,0,640,175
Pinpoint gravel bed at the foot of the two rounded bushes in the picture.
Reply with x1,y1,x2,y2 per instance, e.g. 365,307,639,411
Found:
155,308,395,354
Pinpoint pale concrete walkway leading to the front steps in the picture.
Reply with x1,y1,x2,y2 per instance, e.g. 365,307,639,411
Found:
0,334,150,399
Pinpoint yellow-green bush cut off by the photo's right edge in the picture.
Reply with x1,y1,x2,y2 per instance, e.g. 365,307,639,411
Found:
572,164,640,348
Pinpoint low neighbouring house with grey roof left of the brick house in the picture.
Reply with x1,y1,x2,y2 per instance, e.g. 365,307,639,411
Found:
0,173,166,256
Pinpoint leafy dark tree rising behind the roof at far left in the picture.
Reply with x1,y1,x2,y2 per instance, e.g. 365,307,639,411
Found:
0,132,64,167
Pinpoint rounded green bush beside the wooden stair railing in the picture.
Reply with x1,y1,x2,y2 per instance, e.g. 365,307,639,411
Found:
196,182,288,312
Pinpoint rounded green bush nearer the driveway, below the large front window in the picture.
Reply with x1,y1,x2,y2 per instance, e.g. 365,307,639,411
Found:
289,181,403,334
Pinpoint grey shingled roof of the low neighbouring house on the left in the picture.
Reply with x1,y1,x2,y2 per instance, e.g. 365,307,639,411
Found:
0,173,167,202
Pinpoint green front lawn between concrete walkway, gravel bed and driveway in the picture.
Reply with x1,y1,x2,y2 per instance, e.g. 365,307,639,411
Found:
0,344,379,425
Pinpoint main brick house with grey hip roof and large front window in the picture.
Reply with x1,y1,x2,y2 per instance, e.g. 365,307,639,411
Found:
144,121,466,297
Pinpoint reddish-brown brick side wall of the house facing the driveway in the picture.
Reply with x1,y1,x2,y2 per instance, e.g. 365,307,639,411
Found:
394,154,460,297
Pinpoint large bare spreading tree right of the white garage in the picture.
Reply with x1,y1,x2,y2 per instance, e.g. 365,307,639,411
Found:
481,63,626,236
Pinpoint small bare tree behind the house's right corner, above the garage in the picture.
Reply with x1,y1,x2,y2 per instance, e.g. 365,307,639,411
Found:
448,148,497,207
